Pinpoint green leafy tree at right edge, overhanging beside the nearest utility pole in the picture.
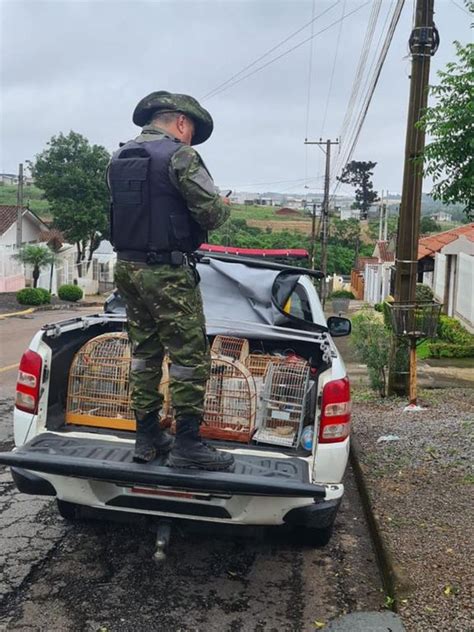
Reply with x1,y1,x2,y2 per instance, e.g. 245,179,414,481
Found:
418,38,474,219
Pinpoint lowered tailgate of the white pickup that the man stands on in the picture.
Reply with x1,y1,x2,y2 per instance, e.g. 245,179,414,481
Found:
0,432,326,499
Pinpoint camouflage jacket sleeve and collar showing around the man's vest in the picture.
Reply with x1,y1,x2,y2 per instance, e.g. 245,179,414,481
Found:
131,125,230,230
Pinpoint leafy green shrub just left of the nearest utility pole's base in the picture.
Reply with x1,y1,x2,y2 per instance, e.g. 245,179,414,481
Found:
352,311,390,397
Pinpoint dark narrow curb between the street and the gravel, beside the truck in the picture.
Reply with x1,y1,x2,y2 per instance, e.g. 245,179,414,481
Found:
350,433,411,612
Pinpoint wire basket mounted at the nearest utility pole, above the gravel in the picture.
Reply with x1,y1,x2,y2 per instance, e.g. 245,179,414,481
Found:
390,302,442,339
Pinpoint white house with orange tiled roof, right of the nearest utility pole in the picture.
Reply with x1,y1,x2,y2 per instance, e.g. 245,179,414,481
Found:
418,223,474,332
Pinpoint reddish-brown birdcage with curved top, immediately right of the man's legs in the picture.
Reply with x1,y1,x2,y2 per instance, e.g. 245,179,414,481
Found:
201,352,257,442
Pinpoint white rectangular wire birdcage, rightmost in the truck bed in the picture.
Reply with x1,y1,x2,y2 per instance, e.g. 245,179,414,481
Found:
254,361,310,447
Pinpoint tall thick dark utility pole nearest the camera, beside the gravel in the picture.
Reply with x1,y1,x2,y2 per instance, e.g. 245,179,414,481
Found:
389,0,439,396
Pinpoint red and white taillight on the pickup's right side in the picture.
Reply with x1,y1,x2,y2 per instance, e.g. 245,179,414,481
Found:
319,377,351,443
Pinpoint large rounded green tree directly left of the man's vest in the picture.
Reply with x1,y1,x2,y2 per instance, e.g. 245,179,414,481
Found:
32,131,110,275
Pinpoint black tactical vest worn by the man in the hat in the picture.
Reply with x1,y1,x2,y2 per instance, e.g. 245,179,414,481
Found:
108,138,206,253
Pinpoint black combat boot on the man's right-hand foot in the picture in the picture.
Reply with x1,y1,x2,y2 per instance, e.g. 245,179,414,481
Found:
168,417,234,471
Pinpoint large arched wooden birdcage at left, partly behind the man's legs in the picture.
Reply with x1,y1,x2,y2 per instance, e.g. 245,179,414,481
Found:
66,332,171,430
